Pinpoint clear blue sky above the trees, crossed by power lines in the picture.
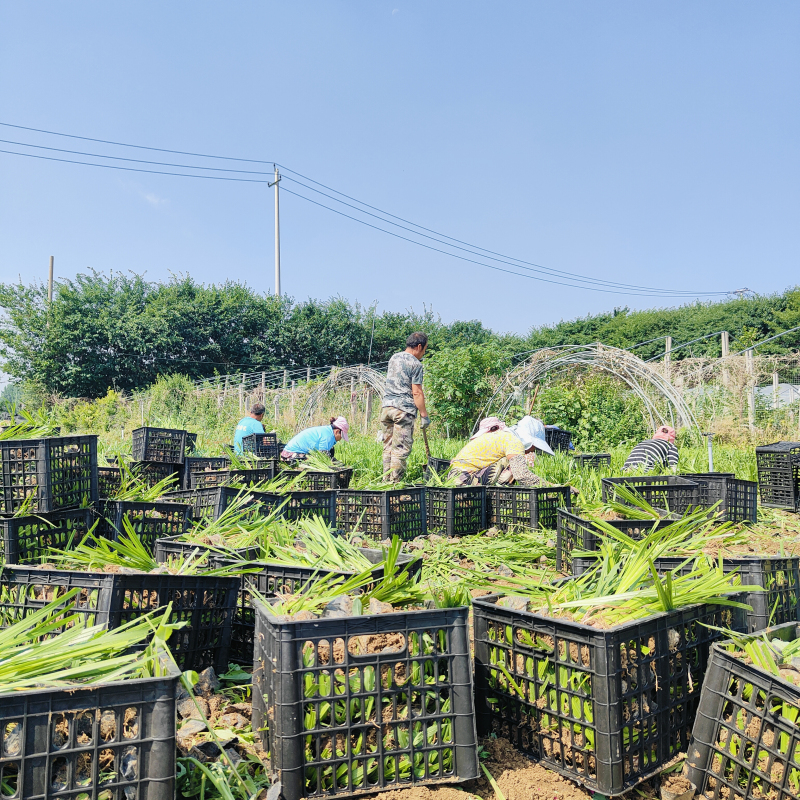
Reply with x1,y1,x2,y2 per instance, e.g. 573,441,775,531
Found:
0,0,800,333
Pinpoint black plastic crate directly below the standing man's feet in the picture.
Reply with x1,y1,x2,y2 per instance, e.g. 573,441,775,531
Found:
336,486,428,541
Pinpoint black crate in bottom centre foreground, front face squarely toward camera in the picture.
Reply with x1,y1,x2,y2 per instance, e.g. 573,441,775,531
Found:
253,600,479,800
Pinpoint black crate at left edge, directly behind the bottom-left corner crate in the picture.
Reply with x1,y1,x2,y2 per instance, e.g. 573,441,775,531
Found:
0,566,239,672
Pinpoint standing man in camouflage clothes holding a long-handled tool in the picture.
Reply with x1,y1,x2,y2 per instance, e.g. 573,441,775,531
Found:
380,332,431,483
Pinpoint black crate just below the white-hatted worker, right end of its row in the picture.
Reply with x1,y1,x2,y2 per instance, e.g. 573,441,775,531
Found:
486,486,572,530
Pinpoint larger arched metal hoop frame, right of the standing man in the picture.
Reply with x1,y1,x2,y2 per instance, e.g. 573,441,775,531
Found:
473,342,699,433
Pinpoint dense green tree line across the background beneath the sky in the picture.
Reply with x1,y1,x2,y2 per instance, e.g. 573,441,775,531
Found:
0,273,800,400
